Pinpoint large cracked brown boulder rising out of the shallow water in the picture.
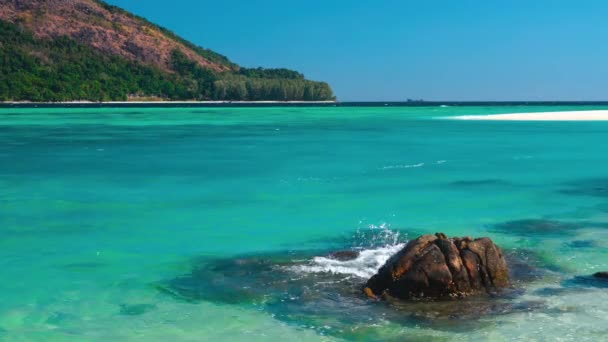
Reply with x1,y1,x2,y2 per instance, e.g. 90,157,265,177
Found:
364,233,510,299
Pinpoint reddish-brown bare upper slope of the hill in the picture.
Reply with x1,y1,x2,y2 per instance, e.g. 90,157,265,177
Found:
0,0,234,71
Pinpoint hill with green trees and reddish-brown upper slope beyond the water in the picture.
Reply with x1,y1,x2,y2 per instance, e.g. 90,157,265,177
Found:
0,0,334,101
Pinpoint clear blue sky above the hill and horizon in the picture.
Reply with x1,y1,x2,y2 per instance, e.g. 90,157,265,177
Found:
108,0,608,101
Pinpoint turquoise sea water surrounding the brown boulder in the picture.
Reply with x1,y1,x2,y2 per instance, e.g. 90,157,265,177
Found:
0,106,608,341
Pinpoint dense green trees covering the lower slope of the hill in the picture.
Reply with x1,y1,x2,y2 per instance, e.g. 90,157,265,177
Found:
0,21,334,101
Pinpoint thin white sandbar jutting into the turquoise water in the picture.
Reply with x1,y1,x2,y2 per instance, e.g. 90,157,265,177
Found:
449,110,608,121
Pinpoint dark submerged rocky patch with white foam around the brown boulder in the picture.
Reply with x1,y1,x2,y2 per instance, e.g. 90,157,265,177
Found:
158,229,560,341
